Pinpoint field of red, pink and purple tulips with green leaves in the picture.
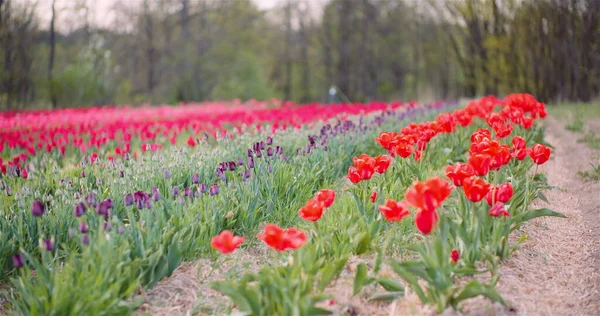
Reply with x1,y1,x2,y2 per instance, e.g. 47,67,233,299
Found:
0,94,563,315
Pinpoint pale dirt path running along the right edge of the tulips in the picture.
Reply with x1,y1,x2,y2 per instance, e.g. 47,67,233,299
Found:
474,118,600,315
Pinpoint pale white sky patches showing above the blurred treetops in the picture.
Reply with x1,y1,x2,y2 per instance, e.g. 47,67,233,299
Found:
31,0,304,31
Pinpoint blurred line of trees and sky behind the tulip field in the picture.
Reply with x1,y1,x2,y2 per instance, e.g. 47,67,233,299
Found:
0,0,600,110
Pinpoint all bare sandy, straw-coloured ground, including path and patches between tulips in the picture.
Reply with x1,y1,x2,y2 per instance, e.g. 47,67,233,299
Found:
137,118,600,315
